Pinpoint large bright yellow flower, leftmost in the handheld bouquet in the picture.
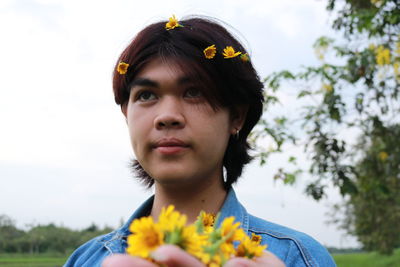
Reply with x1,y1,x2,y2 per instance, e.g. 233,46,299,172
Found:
126,217,164,258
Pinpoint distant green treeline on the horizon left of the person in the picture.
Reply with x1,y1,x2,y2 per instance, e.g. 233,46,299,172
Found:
0,215,113,255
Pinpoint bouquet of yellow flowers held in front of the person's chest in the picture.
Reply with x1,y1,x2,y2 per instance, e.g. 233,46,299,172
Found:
126,205,267,267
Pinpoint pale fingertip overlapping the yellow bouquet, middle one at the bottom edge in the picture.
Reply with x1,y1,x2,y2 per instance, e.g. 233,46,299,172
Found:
151,245,204,267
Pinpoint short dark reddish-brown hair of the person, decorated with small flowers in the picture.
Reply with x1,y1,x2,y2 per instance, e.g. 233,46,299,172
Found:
113,17,264,191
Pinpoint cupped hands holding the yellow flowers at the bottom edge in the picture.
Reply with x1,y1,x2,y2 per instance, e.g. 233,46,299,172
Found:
102,245,285,267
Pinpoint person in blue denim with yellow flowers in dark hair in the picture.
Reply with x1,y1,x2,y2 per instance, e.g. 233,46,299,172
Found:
65,17,335,266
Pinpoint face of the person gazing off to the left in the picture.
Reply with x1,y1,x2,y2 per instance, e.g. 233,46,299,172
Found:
123,59,240,187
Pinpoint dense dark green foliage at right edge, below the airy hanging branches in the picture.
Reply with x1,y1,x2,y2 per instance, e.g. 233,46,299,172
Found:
347,125,400,254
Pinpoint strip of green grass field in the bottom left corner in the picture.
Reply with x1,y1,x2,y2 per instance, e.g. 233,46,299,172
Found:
0,254,67,267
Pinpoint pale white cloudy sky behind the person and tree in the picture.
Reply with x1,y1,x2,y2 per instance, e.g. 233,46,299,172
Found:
0,0,358,247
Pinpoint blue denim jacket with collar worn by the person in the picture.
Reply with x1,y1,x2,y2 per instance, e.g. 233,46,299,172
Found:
64,189,336,267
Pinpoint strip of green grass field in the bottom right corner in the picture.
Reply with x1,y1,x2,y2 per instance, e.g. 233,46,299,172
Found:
333,249,400,267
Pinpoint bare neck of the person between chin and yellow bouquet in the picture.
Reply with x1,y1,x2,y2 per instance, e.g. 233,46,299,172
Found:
151,176,227,223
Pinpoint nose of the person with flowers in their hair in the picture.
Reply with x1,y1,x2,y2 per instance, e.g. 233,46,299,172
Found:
154,97,185,130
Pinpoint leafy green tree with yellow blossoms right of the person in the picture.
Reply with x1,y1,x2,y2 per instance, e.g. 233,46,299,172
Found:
253,0,400,253
